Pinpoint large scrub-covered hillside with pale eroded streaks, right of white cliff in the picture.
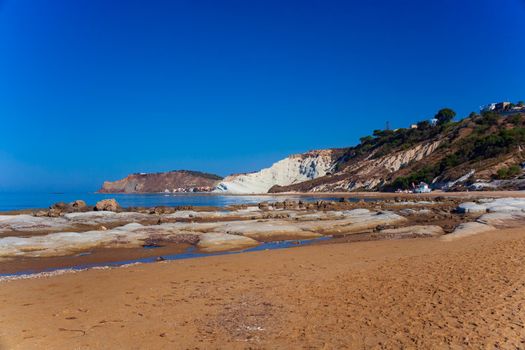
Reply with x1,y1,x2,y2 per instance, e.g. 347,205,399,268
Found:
269,107,525,193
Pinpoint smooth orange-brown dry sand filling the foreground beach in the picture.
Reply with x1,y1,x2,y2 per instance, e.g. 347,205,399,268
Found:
0,228,525,349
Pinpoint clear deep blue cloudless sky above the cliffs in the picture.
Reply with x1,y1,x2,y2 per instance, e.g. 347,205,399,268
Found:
0,0,525,191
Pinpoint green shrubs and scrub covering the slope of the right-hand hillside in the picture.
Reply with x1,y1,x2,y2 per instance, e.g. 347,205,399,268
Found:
336,102,525,190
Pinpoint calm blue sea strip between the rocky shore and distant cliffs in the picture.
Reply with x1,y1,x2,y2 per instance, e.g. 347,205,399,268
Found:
0,192,344,211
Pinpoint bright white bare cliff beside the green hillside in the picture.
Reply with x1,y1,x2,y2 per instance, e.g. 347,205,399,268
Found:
215,149,340,194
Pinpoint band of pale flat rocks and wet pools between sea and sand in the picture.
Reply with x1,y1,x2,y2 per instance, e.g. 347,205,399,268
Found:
0,193,525,276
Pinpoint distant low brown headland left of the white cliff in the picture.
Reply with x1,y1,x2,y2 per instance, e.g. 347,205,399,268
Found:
99,170,222,193
